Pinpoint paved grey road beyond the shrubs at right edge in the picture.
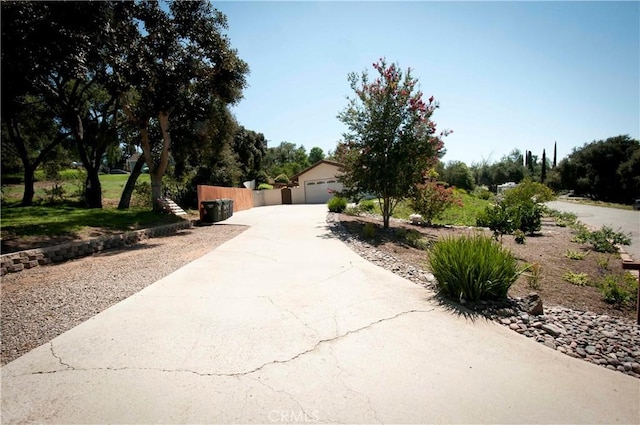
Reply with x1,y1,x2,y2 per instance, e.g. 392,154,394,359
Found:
547,201,640,261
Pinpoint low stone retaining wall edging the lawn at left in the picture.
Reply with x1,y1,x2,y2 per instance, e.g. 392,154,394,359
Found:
0,221,194,276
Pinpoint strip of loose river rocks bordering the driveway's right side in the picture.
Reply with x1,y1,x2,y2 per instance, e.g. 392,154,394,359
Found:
327,213,640,378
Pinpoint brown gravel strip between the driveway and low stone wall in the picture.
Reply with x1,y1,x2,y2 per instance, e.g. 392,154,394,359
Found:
0,224,246,365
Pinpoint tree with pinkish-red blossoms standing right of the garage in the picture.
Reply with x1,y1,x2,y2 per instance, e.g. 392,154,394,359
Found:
337,59,450,228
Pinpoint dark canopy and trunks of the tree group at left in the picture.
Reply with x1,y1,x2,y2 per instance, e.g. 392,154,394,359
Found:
2,0,248,207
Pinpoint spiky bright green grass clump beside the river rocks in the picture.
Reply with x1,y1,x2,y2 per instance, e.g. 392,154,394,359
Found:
429,235,522,301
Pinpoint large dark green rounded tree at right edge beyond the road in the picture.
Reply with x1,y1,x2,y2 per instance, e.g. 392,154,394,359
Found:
556,135,640,203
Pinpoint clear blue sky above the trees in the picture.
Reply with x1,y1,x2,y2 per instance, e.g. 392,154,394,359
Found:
214,1,640,165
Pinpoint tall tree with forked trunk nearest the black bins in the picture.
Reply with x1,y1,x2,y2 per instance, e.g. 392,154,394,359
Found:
118,1,248,209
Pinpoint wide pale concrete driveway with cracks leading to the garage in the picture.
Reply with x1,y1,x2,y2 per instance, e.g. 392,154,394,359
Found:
2,205,640,424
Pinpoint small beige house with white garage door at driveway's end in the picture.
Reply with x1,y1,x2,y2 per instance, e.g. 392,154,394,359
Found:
291,159,342,204
